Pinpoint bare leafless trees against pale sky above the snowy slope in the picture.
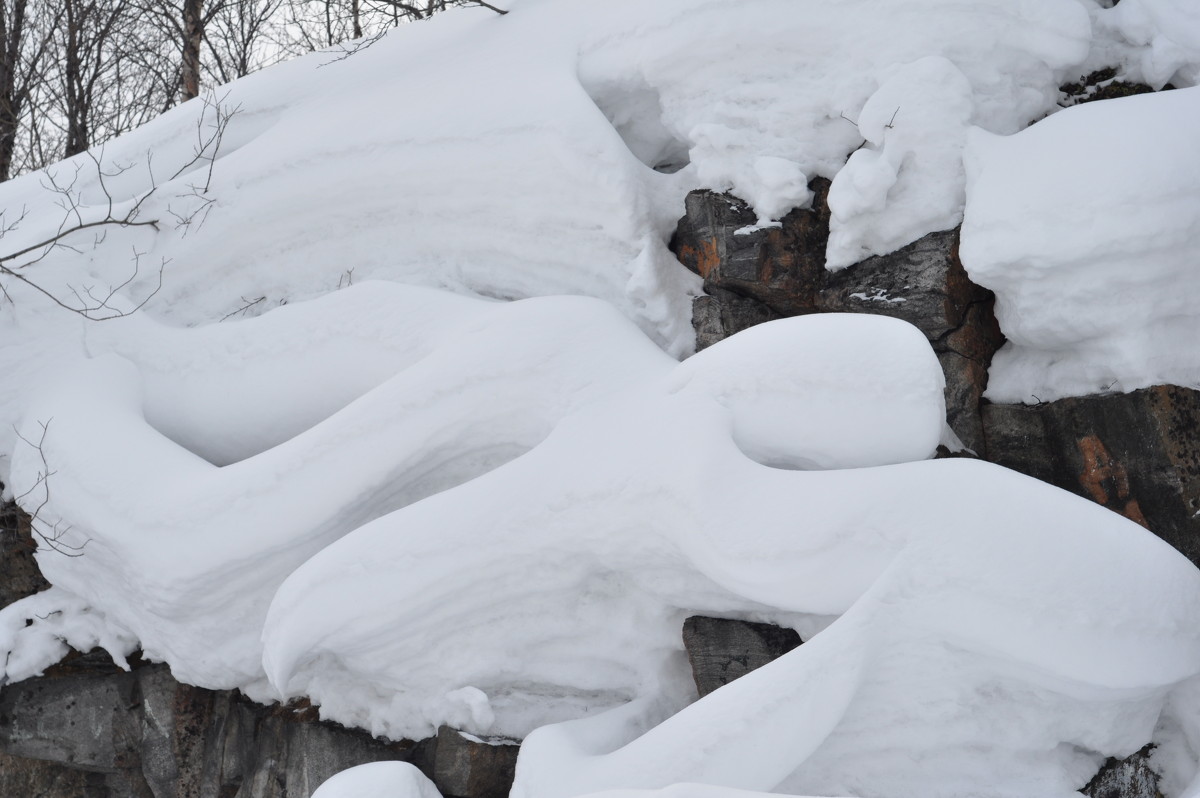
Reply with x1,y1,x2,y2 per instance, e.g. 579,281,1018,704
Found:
0,0,506,181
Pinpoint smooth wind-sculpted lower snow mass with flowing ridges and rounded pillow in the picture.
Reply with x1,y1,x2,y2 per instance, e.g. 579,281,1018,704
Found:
7,283,1200,798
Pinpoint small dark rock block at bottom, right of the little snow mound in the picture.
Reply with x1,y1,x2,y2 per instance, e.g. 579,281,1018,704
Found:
416,726,520,798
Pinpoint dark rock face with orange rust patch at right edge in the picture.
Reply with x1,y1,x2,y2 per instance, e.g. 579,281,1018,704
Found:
983,385,1200,563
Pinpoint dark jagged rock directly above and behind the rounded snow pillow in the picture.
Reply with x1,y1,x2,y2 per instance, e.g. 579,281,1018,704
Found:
672,180,1003,454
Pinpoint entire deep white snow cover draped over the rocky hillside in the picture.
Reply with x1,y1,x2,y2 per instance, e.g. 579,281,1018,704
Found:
0,0,1200,798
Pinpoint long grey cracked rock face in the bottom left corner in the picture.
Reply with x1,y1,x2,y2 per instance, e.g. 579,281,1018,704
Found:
0,653,413,798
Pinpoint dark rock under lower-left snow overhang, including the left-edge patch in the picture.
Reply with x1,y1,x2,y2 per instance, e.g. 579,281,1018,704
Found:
0,504,517,798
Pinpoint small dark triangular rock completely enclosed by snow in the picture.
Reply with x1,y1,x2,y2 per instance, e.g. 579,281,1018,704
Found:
683,616,802,697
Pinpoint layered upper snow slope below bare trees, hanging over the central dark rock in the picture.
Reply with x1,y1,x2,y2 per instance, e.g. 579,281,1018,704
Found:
0,0,1161,478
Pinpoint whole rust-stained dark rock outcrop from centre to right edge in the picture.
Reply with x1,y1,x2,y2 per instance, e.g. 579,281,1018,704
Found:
672,182,1200,573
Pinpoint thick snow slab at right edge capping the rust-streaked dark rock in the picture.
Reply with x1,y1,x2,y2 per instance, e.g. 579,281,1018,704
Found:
960,85,1200,402
